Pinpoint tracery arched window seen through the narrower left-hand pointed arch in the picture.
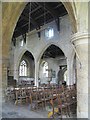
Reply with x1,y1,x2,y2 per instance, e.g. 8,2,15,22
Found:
19,60,27,76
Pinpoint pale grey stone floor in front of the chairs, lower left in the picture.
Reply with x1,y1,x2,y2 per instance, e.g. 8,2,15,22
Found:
2,103,76,118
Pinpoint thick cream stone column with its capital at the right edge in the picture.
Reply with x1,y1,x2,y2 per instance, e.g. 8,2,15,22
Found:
72,33,90,118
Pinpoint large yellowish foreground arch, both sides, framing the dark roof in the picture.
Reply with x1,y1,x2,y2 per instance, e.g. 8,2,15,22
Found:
2,0,77,57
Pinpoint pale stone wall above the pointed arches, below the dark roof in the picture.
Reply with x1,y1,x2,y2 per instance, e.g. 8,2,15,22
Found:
9,15,74,83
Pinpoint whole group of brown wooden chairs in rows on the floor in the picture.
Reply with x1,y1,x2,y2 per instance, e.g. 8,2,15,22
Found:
5,85,77,117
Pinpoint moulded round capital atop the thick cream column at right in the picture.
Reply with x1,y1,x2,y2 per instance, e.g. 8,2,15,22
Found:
71,32,90,46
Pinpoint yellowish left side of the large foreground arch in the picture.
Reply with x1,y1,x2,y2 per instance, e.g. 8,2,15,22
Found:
2,2,26,59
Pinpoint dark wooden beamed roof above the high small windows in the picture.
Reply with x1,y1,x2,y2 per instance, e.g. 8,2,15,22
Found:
13,2,67,38
